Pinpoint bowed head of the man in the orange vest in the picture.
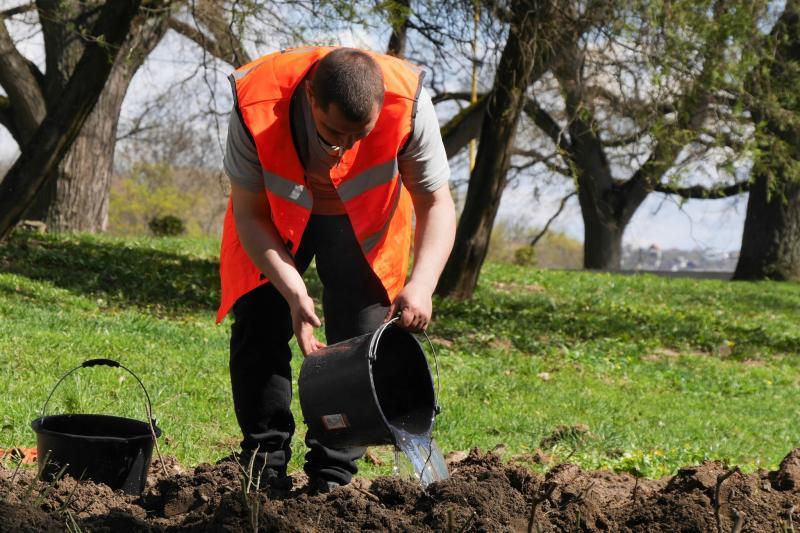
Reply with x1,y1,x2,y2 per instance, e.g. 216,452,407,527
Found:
307,48,383,149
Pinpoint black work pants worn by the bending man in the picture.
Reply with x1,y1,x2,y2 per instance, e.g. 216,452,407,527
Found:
230,215,389,484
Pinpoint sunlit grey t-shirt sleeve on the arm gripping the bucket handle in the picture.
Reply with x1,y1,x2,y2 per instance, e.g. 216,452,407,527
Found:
397,87,450,193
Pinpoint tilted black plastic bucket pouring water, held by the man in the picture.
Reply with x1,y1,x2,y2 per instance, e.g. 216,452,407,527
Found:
298,322,439,448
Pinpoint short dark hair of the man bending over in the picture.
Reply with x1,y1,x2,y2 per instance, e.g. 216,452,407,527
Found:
311,48,383,122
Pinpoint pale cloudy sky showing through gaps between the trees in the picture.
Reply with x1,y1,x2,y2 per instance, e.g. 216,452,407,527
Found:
0,1,747,252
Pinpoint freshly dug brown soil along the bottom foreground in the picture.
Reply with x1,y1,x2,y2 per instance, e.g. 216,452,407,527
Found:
0,449,800,533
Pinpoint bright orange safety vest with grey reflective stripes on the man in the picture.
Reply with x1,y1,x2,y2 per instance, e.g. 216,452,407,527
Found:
212,47,422,323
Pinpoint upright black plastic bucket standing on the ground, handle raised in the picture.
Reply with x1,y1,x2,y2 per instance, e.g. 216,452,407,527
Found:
31,359,161,494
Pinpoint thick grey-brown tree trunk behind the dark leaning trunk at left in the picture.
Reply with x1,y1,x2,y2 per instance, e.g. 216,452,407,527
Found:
0,0,170,231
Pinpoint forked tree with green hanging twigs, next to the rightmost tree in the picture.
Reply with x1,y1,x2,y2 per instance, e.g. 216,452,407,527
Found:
521,0,764,270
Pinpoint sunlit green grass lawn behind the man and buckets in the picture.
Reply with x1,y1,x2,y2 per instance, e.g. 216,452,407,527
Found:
0,234,800,477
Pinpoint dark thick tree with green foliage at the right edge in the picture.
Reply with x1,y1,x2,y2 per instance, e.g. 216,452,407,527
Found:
734,0,800,280
